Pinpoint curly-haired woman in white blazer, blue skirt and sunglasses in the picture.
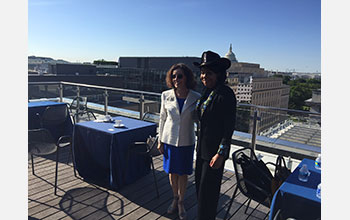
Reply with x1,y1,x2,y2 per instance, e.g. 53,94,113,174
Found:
158,63,200,219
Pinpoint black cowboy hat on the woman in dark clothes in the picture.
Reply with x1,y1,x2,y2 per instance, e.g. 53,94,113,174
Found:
193,50,231,70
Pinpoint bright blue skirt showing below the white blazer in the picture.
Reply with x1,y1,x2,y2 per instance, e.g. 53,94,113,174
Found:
163,144,194,175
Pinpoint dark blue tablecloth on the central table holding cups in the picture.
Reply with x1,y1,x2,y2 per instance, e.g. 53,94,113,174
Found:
73,116,157,190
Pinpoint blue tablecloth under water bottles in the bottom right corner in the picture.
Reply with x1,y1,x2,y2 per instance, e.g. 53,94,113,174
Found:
269,159,321,220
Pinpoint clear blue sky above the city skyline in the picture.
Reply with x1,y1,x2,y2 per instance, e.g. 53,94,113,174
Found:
28,0,321,72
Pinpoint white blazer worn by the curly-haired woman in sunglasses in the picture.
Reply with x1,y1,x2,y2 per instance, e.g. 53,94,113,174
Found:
159,89,200,147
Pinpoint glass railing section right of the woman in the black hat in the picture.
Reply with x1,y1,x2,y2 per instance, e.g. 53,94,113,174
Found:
232,103,321,158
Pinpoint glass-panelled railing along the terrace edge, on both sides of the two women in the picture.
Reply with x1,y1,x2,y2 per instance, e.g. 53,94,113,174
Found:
28,82,321,158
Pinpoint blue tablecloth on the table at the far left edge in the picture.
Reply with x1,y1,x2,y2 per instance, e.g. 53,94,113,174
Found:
28,101,73,141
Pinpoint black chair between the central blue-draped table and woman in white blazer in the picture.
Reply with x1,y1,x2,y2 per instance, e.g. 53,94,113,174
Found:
125,136,160,198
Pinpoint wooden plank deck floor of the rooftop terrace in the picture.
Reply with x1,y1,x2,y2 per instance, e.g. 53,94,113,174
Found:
28,146,269,220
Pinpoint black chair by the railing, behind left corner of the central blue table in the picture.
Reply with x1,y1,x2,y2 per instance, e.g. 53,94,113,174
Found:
68,96,96,124
